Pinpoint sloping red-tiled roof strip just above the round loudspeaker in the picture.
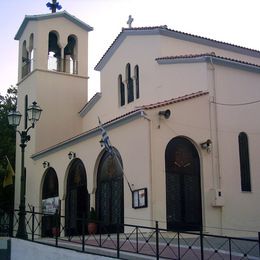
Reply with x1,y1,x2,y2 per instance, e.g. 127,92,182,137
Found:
137,91,209,110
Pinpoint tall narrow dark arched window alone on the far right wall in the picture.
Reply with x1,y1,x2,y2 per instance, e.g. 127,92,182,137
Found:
238,132,251,191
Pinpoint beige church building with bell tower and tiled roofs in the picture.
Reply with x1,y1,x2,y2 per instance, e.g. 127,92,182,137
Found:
15,8,260,236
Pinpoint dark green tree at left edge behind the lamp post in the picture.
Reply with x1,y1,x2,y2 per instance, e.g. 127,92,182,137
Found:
0,86,17,210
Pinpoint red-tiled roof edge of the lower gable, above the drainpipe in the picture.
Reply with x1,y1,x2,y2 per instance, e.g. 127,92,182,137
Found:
155,52,260,68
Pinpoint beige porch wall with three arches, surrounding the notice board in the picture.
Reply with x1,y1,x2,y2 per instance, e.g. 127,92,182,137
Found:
23,118,152,228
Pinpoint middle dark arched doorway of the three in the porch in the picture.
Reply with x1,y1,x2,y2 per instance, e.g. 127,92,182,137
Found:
65,159,89,236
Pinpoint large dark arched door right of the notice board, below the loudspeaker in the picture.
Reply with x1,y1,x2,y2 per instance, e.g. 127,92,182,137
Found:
165,137,202,230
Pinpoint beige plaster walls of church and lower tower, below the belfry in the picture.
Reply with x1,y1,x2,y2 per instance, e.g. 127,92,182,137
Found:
13,20,260,234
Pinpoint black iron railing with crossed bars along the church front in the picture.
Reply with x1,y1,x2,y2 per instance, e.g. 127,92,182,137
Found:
0,208,260,259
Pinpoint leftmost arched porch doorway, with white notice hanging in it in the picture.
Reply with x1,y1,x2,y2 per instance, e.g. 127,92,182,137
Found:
42,167,59,237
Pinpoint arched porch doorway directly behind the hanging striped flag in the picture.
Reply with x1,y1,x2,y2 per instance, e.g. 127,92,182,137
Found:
96,152,124,233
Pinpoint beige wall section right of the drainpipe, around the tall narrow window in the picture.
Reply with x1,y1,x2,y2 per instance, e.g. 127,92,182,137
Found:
210,66,260,234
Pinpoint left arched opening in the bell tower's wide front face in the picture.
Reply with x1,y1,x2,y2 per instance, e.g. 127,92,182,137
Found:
48,31,62,71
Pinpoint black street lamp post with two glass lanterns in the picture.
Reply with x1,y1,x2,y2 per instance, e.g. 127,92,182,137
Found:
8,102,42,239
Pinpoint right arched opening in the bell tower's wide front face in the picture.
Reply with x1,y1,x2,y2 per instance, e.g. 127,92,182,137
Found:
64,35,78,74
